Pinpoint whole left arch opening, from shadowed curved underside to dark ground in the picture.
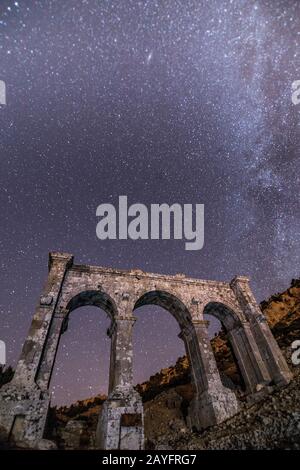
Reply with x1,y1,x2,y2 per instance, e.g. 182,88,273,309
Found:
43,290,116,449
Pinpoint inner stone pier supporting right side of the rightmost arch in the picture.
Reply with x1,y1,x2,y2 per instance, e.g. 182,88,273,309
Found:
227,322,271,394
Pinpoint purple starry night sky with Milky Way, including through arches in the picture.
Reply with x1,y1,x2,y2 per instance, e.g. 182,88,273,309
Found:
0,0,300,403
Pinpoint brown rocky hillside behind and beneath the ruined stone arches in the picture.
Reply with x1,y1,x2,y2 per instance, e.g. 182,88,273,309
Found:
45,279,300,449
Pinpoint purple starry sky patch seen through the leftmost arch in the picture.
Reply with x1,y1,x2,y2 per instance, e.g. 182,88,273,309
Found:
49,306,111,407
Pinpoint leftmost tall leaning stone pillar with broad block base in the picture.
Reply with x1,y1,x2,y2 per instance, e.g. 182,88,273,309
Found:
0,253,73,447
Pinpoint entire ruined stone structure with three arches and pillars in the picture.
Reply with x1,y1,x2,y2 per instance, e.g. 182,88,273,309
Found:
0,252,291,449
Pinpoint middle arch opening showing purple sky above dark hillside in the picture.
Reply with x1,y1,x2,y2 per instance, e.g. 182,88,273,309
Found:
133,291,195,449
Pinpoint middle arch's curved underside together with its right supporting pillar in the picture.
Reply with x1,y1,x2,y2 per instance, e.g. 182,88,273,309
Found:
134,290,238,429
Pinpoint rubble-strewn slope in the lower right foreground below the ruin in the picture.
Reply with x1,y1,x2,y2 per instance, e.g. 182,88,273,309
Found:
149,373,300,450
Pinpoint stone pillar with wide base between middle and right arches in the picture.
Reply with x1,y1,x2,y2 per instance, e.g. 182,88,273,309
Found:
180,320,239,430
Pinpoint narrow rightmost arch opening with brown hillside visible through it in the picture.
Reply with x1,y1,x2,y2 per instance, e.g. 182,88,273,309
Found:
203,302,246,396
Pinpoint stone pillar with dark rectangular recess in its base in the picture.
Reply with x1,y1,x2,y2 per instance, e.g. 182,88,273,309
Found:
96,316,144,450
